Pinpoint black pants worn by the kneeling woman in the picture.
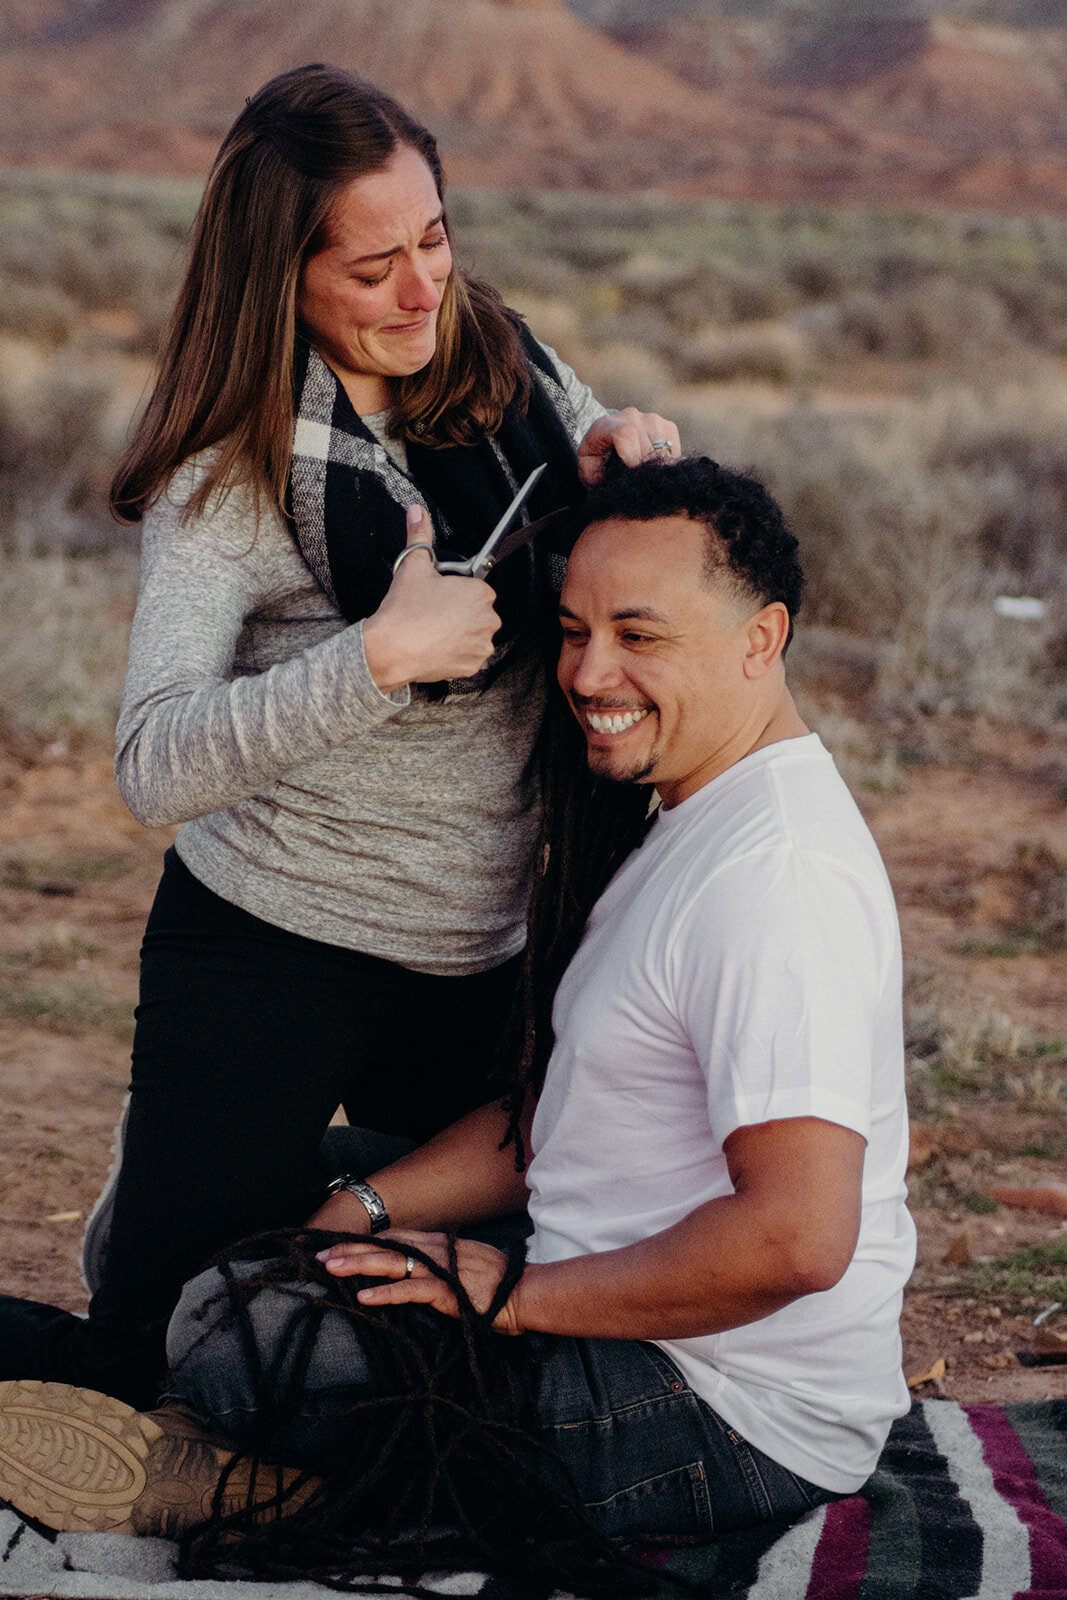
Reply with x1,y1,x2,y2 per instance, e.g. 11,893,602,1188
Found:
0,850,518,1406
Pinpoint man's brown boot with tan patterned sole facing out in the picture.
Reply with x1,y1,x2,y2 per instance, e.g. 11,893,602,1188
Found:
0,1378,315,1539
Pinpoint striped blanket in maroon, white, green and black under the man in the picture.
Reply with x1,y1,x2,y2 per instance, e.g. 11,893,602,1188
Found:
0,1400,1067,1600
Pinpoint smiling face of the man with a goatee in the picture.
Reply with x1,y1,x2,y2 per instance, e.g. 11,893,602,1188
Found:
558,517,757,806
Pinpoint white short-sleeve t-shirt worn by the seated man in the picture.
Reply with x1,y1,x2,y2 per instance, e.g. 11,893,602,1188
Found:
530,734,915,1493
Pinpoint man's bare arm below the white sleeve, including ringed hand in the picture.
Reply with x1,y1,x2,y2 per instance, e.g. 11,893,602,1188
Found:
328,1117,865,1339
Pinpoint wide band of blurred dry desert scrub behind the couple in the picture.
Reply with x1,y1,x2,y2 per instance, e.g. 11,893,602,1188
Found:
0,171,1067,738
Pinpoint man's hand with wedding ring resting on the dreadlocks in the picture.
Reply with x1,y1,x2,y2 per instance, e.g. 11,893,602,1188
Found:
318,1222,523,1333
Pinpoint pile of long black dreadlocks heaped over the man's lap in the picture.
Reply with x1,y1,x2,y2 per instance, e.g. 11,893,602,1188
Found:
171,1229,686,1600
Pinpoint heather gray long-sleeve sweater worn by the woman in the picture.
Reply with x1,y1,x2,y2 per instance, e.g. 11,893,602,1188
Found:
115,352,603,974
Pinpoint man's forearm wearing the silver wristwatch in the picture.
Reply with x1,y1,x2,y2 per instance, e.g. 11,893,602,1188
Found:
307,1101,533,1234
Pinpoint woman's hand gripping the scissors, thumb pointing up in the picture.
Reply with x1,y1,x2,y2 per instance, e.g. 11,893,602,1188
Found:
363,506,501,694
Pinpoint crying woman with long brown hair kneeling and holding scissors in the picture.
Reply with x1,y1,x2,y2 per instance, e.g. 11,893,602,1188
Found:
0,66,678,1405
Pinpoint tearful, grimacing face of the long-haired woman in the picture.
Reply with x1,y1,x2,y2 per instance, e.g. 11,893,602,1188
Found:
298,144,453,416
